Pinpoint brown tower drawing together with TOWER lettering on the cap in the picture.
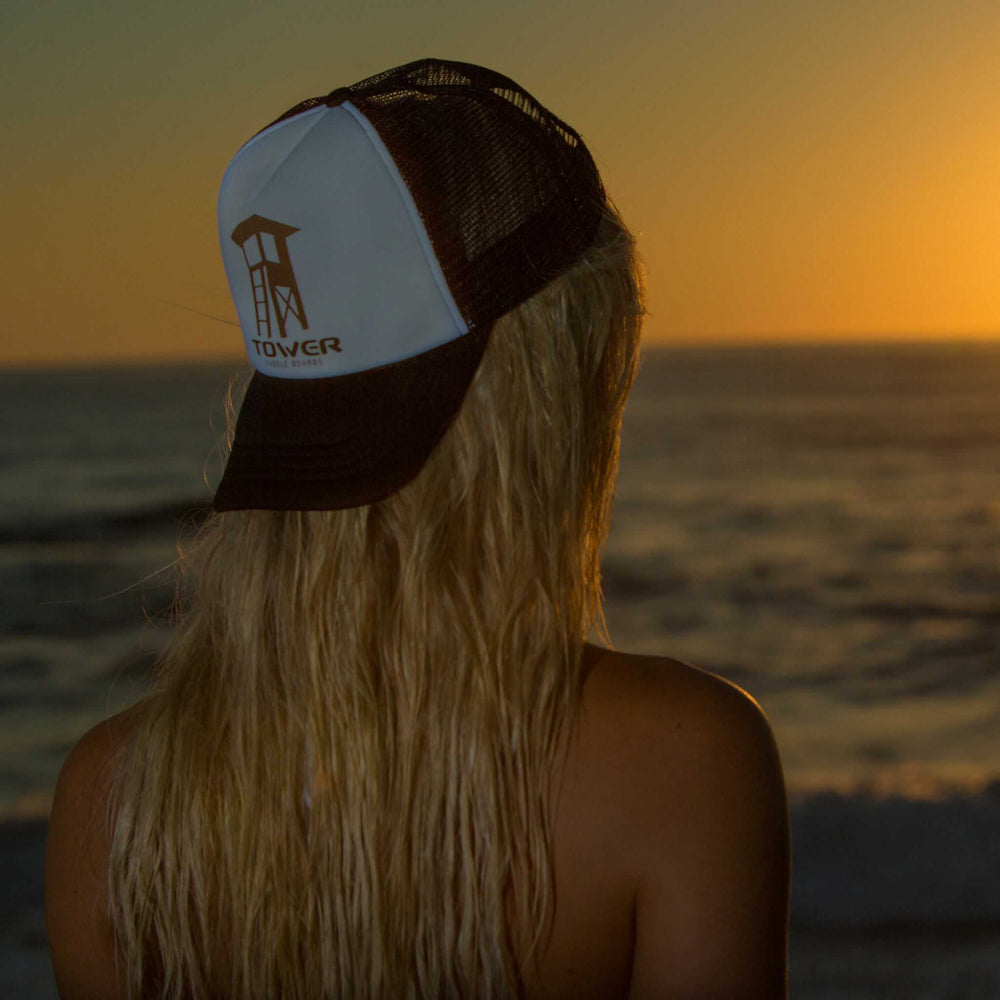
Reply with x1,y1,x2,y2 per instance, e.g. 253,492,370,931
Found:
231,215,340,367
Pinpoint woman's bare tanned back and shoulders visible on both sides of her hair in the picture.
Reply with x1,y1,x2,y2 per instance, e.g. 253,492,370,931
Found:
46,646,789,1000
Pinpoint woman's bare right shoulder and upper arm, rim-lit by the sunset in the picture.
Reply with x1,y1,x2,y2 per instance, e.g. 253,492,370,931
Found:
584,651,790,998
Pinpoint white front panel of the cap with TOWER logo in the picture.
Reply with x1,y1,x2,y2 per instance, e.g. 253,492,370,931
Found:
219,103,468,378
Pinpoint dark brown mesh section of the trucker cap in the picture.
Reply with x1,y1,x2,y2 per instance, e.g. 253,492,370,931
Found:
336,60,604,326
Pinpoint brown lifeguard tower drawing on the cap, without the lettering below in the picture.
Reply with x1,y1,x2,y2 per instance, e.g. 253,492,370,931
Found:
231,215,309,338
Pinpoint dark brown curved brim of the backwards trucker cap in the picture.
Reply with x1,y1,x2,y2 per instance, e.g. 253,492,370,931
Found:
214,330,489,511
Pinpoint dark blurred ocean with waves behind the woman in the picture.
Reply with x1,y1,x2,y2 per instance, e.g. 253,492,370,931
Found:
0,343,1000,1000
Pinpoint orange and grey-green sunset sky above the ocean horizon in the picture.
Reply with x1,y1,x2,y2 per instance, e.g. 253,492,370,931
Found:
0,0,1000,364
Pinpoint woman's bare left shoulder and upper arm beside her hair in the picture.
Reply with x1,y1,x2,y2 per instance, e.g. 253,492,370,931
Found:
45,708,146,1000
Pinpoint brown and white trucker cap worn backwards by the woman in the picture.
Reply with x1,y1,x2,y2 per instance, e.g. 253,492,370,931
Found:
215,59,606,511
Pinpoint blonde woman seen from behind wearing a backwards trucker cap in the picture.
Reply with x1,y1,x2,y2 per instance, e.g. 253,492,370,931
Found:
46,60,789,998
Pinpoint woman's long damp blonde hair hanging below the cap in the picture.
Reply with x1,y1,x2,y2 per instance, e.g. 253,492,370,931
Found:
109,203,644,1000
